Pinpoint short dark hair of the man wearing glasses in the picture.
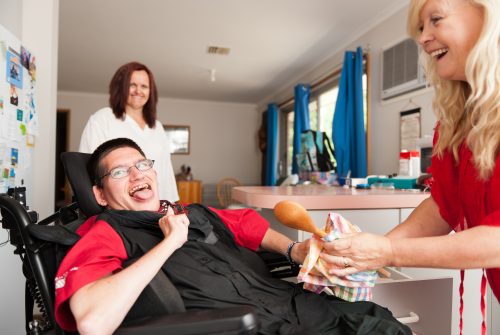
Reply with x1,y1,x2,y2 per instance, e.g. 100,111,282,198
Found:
87,137,146,188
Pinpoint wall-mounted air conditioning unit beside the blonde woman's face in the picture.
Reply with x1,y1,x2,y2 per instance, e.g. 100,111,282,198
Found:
381,38,425,100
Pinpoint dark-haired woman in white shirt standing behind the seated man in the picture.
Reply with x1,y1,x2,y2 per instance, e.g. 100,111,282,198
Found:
79,62,179,202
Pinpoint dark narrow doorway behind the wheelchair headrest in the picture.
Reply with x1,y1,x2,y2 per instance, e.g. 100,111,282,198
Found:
54,109,71,211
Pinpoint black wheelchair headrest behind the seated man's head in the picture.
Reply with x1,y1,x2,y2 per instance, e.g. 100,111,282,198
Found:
61,152,103,217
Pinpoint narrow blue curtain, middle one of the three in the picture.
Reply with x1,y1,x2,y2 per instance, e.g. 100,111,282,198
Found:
292,84,311,173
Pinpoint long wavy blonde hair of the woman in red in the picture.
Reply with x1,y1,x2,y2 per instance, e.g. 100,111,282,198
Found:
408,0,500,180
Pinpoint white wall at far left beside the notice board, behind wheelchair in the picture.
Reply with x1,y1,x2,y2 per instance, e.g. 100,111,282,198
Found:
0,0,59,334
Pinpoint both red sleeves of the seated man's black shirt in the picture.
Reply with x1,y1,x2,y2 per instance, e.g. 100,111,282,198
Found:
55,208,269,331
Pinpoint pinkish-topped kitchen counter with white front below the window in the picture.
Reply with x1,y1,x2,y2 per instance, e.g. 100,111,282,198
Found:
232,185,430,241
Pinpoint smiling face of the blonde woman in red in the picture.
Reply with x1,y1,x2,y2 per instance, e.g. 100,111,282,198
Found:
419,0,483,81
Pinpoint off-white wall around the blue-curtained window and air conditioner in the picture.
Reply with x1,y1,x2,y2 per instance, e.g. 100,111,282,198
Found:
259,7,436,174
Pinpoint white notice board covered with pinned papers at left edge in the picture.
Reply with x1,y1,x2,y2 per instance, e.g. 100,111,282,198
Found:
0,25,38,193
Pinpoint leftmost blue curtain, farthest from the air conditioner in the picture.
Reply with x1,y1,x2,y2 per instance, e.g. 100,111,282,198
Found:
265,103,279,186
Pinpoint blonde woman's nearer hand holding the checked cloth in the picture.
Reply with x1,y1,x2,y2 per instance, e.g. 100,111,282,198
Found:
320,233,394,277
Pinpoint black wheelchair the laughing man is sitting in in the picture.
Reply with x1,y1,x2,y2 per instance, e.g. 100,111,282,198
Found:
0,152,299,335
